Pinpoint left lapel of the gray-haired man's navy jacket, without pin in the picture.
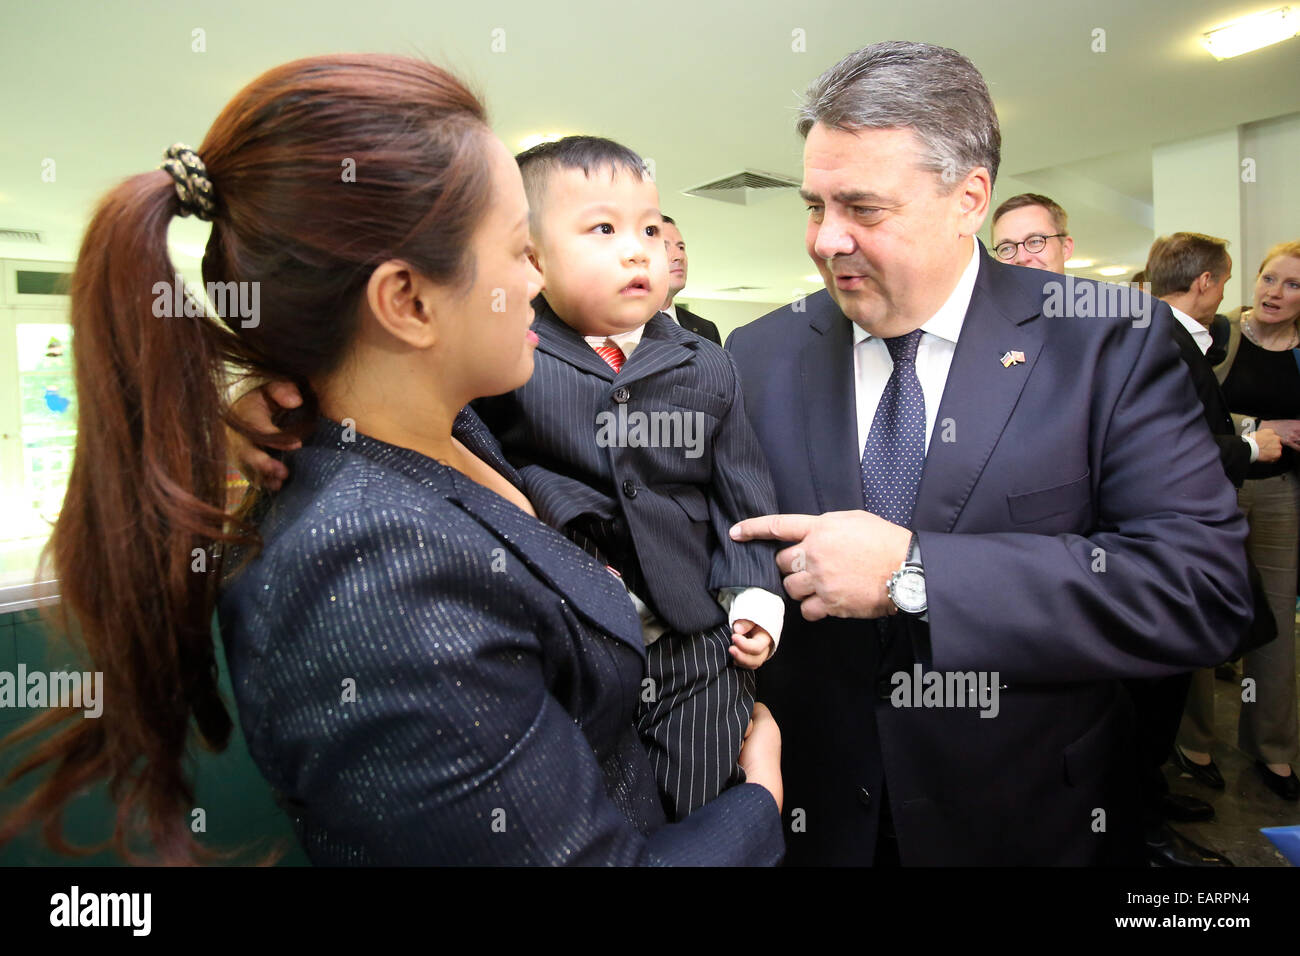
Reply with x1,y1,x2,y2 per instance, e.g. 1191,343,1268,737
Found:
800,290,862,511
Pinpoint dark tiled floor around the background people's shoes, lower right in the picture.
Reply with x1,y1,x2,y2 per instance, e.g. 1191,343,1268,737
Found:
1165,650,1300,866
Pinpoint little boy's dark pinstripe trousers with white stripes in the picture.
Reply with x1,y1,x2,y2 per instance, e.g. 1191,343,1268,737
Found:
564,515,755,822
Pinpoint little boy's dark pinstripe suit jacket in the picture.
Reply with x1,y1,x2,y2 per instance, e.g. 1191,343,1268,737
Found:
475,295,783,633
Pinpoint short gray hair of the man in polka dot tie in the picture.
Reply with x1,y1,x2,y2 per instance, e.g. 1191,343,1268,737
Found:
798,40,1002,186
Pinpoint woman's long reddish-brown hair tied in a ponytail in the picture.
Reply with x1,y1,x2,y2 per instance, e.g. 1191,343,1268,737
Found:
0,55,490,862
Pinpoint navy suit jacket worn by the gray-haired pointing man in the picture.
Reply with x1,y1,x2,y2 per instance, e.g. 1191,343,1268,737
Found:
728,247,1251,865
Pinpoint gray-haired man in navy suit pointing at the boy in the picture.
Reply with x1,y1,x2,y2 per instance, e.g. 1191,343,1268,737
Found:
728,43,1251,865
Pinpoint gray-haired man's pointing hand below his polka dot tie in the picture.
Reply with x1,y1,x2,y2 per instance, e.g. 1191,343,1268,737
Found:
731,511,911,620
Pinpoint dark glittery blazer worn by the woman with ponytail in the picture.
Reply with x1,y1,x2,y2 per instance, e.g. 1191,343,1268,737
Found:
218,410,784,865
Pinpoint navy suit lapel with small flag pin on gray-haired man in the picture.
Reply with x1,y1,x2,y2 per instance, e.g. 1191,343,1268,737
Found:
913,257,1060,532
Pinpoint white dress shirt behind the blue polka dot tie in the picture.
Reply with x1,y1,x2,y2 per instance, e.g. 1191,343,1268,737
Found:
853,239,979,459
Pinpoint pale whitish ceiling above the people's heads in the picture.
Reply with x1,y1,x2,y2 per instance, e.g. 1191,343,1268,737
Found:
0,0,1300,302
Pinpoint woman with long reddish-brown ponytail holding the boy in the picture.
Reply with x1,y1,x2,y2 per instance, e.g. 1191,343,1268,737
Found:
0,55,781,864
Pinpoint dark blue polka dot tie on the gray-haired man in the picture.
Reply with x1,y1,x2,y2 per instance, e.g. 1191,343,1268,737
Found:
862,329,926,528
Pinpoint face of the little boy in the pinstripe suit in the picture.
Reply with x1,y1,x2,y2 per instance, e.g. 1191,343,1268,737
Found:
533,169,668,336
